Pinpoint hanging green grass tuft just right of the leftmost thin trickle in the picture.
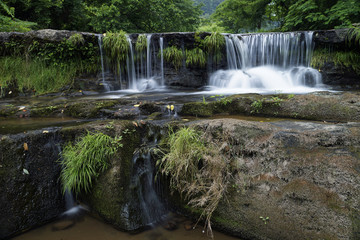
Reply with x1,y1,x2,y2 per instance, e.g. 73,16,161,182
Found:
103,30,130,63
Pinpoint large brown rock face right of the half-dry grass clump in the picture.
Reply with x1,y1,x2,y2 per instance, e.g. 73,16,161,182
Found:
170,119,360,239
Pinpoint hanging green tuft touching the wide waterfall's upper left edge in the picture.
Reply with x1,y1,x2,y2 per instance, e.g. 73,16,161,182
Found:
204,32,225,63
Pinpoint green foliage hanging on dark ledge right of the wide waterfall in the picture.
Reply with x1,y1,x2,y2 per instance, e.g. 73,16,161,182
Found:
311,49,360,74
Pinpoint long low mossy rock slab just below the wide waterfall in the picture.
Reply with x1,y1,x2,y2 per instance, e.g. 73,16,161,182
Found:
180,92,360,121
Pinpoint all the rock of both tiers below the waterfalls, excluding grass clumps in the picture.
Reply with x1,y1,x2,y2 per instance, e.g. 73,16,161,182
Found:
0,92,360,239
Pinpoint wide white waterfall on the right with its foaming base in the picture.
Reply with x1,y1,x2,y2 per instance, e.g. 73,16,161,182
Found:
209,32,322,92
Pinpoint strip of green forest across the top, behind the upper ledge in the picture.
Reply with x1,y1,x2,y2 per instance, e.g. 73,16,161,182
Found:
0,0,360,33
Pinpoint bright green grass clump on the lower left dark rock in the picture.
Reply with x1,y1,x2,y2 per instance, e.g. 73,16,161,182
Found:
61,132,122,194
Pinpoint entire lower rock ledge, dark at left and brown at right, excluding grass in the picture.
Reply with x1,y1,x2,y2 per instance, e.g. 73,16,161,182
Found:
0,116,360,240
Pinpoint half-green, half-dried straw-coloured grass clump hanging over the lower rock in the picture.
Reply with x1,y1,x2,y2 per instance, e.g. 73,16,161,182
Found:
157,127,231,237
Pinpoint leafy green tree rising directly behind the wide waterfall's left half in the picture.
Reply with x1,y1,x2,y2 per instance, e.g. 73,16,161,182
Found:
213,0,271,32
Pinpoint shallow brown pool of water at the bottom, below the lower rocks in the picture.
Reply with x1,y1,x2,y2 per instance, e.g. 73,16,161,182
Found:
13,216,239,240
